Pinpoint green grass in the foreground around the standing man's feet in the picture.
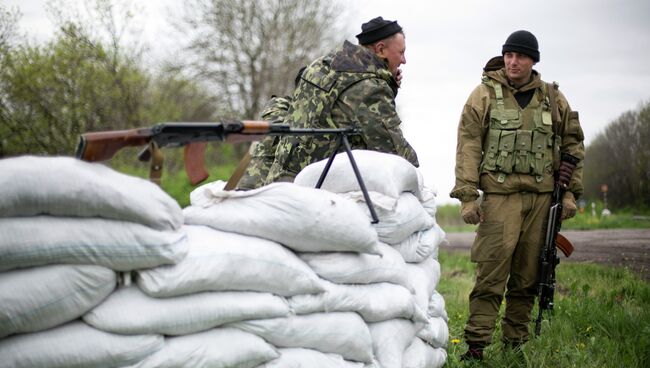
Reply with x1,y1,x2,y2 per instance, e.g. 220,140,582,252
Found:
438,251,650,368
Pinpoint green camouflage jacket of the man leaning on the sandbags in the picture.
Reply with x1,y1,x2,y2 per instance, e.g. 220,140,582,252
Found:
267,41,418,183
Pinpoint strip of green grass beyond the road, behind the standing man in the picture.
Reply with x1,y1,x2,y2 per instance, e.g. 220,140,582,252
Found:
436,202,650,233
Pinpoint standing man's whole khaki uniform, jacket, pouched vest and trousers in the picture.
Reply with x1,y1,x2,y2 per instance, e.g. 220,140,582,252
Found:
450,62,584,347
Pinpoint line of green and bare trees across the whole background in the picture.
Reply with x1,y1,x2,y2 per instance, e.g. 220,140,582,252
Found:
0,0,650,208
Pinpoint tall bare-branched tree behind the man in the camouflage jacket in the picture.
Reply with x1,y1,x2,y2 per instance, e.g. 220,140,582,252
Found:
177,0,345,119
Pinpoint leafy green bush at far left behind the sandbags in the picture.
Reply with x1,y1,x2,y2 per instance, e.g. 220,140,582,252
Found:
0,24,146,155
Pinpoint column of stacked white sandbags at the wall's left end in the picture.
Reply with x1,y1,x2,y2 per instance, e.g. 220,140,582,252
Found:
0,156,187,367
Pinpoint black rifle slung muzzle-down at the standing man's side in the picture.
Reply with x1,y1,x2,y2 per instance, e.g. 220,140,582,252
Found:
535,153,580,336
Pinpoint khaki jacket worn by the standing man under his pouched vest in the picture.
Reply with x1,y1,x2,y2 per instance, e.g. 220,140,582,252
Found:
450,69,584,202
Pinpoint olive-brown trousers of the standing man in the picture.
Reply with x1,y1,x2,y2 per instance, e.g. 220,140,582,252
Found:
465,192,551,346
